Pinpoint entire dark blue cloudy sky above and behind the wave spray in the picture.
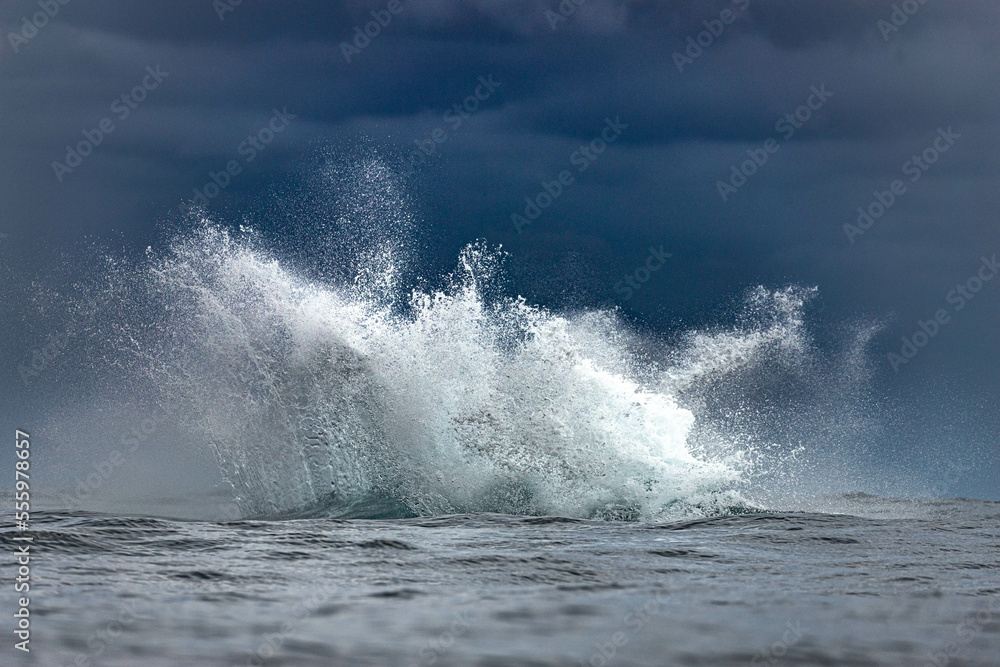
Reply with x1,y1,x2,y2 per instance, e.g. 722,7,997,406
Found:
0,0,1000,496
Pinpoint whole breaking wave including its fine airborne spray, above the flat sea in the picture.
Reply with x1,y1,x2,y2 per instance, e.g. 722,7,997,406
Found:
33,155,877,520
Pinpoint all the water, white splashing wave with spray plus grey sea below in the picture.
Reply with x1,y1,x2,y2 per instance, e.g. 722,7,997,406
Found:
11,175,1000,667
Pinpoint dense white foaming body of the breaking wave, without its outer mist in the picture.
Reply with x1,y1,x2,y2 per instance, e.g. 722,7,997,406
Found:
143,224,804,519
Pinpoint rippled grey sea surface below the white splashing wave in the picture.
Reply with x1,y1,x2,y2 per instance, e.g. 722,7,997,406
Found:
0,494,1000,667
